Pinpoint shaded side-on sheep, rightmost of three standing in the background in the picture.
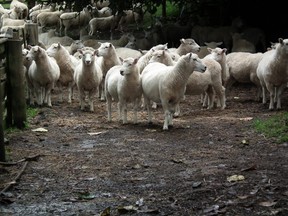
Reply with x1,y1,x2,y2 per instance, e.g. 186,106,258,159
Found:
89,15,119,40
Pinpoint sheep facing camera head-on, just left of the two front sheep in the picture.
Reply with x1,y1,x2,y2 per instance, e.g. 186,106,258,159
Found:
74,49,103,112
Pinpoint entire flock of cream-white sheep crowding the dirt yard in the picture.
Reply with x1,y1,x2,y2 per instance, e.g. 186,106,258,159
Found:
1,0,288,130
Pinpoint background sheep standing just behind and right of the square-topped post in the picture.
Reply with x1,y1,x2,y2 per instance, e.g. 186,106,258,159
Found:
37,10,63,30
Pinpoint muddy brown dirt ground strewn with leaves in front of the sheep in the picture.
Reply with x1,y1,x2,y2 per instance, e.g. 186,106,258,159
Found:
0,85,288,216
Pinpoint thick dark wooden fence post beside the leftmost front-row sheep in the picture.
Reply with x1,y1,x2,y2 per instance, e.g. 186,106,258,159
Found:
7,39,26,129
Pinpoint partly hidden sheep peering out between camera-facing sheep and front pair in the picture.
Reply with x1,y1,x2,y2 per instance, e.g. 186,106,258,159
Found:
96,42,121,101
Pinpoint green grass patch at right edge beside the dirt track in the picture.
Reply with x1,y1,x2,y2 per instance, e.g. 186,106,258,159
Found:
253,112,288,143
